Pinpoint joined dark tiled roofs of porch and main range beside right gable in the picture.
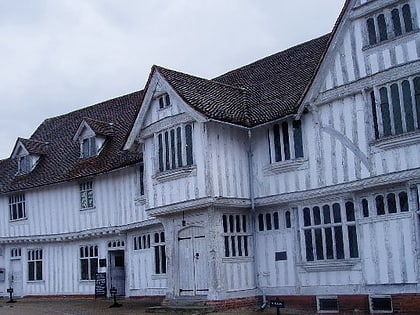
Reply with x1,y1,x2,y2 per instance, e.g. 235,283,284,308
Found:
153,34,330,127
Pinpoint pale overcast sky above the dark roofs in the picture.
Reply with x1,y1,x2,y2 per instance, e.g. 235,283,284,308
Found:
0,0,344,159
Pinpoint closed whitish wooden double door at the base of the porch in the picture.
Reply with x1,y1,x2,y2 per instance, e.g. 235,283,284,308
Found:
178,227,208,296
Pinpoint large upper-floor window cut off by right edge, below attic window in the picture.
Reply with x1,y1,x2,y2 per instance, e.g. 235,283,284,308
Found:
370,77,420,139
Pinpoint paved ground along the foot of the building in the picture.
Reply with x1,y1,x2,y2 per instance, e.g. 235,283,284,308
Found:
0,298,286,315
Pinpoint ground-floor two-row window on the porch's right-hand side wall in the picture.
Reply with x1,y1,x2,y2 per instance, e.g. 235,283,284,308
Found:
222,214,251,257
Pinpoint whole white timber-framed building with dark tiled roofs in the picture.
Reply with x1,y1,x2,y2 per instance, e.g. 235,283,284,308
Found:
0,0,420,314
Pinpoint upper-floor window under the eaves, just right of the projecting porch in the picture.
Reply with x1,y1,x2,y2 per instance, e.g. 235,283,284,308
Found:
268,120,303,163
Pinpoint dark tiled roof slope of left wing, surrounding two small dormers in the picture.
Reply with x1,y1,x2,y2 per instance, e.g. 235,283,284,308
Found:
0,91,143,193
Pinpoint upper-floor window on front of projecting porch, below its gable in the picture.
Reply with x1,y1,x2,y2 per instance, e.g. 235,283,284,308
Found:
157,124,194,172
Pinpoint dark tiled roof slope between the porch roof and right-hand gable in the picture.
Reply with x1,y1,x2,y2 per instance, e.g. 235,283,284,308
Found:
213,34,330,126
